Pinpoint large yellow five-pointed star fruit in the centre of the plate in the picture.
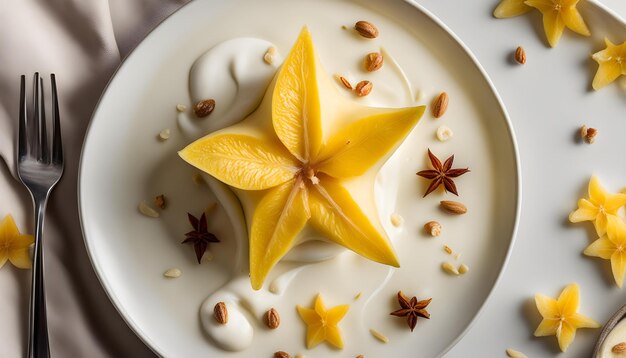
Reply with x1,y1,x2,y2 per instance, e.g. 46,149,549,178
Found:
179,27,424,290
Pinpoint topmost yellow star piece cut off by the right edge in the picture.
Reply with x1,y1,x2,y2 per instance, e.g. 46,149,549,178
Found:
591,38,626,90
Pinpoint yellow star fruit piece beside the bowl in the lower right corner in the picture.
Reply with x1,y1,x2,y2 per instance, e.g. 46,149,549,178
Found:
535,283,600,352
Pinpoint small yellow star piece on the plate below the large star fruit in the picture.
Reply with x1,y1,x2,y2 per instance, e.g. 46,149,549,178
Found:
296,295,350,349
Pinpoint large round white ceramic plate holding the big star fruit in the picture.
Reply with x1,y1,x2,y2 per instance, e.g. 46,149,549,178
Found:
79,0,521,357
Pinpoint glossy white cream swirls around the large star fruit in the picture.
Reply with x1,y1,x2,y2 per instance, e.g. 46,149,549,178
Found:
178,38,415,351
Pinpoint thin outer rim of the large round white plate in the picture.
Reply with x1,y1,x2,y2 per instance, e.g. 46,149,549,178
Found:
77,0,520,357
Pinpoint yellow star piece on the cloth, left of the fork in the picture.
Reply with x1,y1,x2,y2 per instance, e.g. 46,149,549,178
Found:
0,215,35,269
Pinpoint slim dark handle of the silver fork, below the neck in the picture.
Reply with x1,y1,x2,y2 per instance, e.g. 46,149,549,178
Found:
28,197,50,358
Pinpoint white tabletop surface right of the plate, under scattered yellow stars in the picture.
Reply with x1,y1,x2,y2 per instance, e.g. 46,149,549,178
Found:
419,0,626,357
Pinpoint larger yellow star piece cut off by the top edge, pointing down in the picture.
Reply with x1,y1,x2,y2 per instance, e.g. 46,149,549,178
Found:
525,0,591,47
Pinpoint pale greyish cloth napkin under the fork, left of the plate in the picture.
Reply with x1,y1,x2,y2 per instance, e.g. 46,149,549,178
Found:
0,0,186,358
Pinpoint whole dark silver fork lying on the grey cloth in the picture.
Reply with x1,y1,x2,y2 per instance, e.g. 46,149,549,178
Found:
17,72,63,358
